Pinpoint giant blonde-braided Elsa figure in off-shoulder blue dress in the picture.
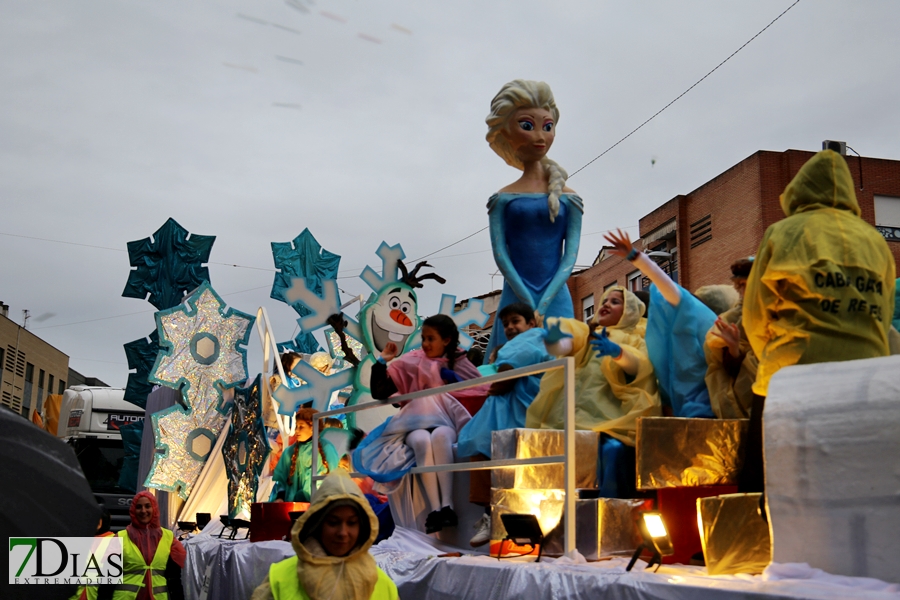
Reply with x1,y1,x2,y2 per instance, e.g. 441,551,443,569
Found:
485,79,584,356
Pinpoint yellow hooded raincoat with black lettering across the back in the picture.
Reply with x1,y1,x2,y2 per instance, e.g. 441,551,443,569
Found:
744,150,896,396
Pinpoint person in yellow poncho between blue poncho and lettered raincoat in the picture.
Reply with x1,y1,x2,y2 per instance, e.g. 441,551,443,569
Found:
703,257,758,419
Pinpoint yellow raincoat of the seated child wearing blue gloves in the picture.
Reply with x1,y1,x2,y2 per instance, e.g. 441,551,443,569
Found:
525,286,662,446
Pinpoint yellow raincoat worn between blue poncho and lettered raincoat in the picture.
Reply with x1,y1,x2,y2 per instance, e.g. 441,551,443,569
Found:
703,303,759,419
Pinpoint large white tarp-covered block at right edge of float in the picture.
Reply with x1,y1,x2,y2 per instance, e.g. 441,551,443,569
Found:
764,356,900,583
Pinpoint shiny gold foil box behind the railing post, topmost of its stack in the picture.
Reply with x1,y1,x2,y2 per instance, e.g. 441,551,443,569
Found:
491,429,600,490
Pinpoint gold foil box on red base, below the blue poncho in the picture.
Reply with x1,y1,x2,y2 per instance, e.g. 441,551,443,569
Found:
637,417,749,490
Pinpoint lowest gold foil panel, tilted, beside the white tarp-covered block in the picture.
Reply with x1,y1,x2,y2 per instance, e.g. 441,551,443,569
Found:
697,494,772,575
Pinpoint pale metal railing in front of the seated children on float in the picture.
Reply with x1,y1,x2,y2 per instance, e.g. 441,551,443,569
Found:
311,357,575,552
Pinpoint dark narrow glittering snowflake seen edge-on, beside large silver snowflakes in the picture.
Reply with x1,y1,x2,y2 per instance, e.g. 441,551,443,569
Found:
222,375,269,518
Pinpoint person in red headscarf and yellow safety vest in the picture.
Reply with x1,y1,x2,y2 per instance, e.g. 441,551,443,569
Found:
97,492,186,600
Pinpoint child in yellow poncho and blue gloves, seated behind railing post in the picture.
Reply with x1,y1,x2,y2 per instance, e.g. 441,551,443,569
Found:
525,286,662,497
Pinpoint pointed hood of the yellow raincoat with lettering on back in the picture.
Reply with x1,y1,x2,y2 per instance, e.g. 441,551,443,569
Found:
781,150,860,217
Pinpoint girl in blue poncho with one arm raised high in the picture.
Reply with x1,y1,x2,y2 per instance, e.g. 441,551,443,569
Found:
605,230,716,418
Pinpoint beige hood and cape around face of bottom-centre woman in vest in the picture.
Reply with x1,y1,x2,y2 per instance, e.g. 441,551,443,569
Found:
291,469,378,600
